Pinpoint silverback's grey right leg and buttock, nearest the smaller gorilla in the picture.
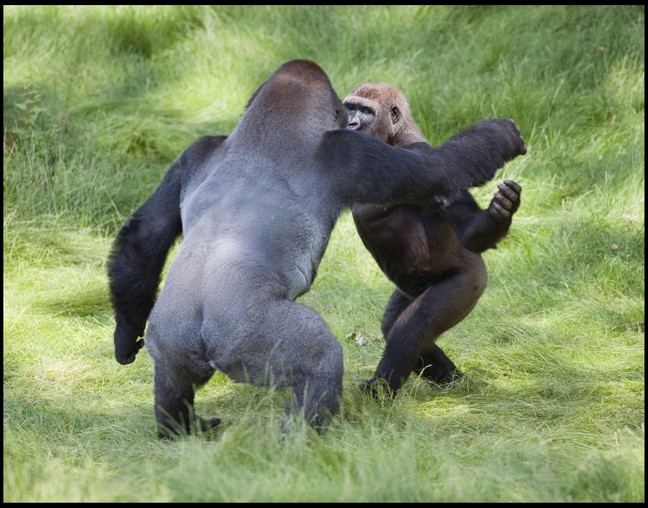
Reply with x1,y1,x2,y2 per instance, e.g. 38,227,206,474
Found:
203,294,344,431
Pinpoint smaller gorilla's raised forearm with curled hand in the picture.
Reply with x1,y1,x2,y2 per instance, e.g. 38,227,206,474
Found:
439,180,522,254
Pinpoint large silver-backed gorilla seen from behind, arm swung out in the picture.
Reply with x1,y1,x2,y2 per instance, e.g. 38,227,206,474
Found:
108,60,526,438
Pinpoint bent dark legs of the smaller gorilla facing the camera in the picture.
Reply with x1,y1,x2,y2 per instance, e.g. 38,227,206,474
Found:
368,253,487,395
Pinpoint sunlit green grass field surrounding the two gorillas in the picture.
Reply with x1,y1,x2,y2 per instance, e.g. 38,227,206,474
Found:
3,6,645,502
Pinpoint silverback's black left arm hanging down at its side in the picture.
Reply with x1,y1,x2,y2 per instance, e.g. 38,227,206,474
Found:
108,137,225,365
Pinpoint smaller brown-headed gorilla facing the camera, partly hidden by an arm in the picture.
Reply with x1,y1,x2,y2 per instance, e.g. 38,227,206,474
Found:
343,83,522,397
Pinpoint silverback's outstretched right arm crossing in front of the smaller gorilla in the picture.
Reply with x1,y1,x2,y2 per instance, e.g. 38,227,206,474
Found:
319,119,526,206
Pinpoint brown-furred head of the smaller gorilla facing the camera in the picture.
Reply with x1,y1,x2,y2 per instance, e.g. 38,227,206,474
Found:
342,83,426,148
